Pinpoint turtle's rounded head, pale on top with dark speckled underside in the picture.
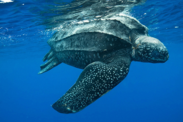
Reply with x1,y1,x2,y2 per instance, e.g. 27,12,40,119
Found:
132,36,169,63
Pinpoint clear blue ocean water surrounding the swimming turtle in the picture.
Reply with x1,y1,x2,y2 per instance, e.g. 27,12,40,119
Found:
0,0,183,122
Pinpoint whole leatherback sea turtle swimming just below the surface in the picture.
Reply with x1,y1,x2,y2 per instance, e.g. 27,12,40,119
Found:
39,14,169,113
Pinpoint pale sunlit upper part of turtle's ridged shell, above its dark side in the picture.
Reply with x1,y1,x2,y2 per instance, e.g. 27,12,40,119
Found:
48,14,147,46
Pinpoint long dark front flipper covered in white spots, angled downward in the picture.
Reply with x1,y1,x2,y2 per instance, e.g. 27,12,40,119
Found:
52,56,131,114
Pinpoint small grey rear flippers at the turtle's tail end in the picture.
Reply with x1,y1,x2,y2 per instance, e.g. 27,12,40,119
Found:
38,50,61,74
